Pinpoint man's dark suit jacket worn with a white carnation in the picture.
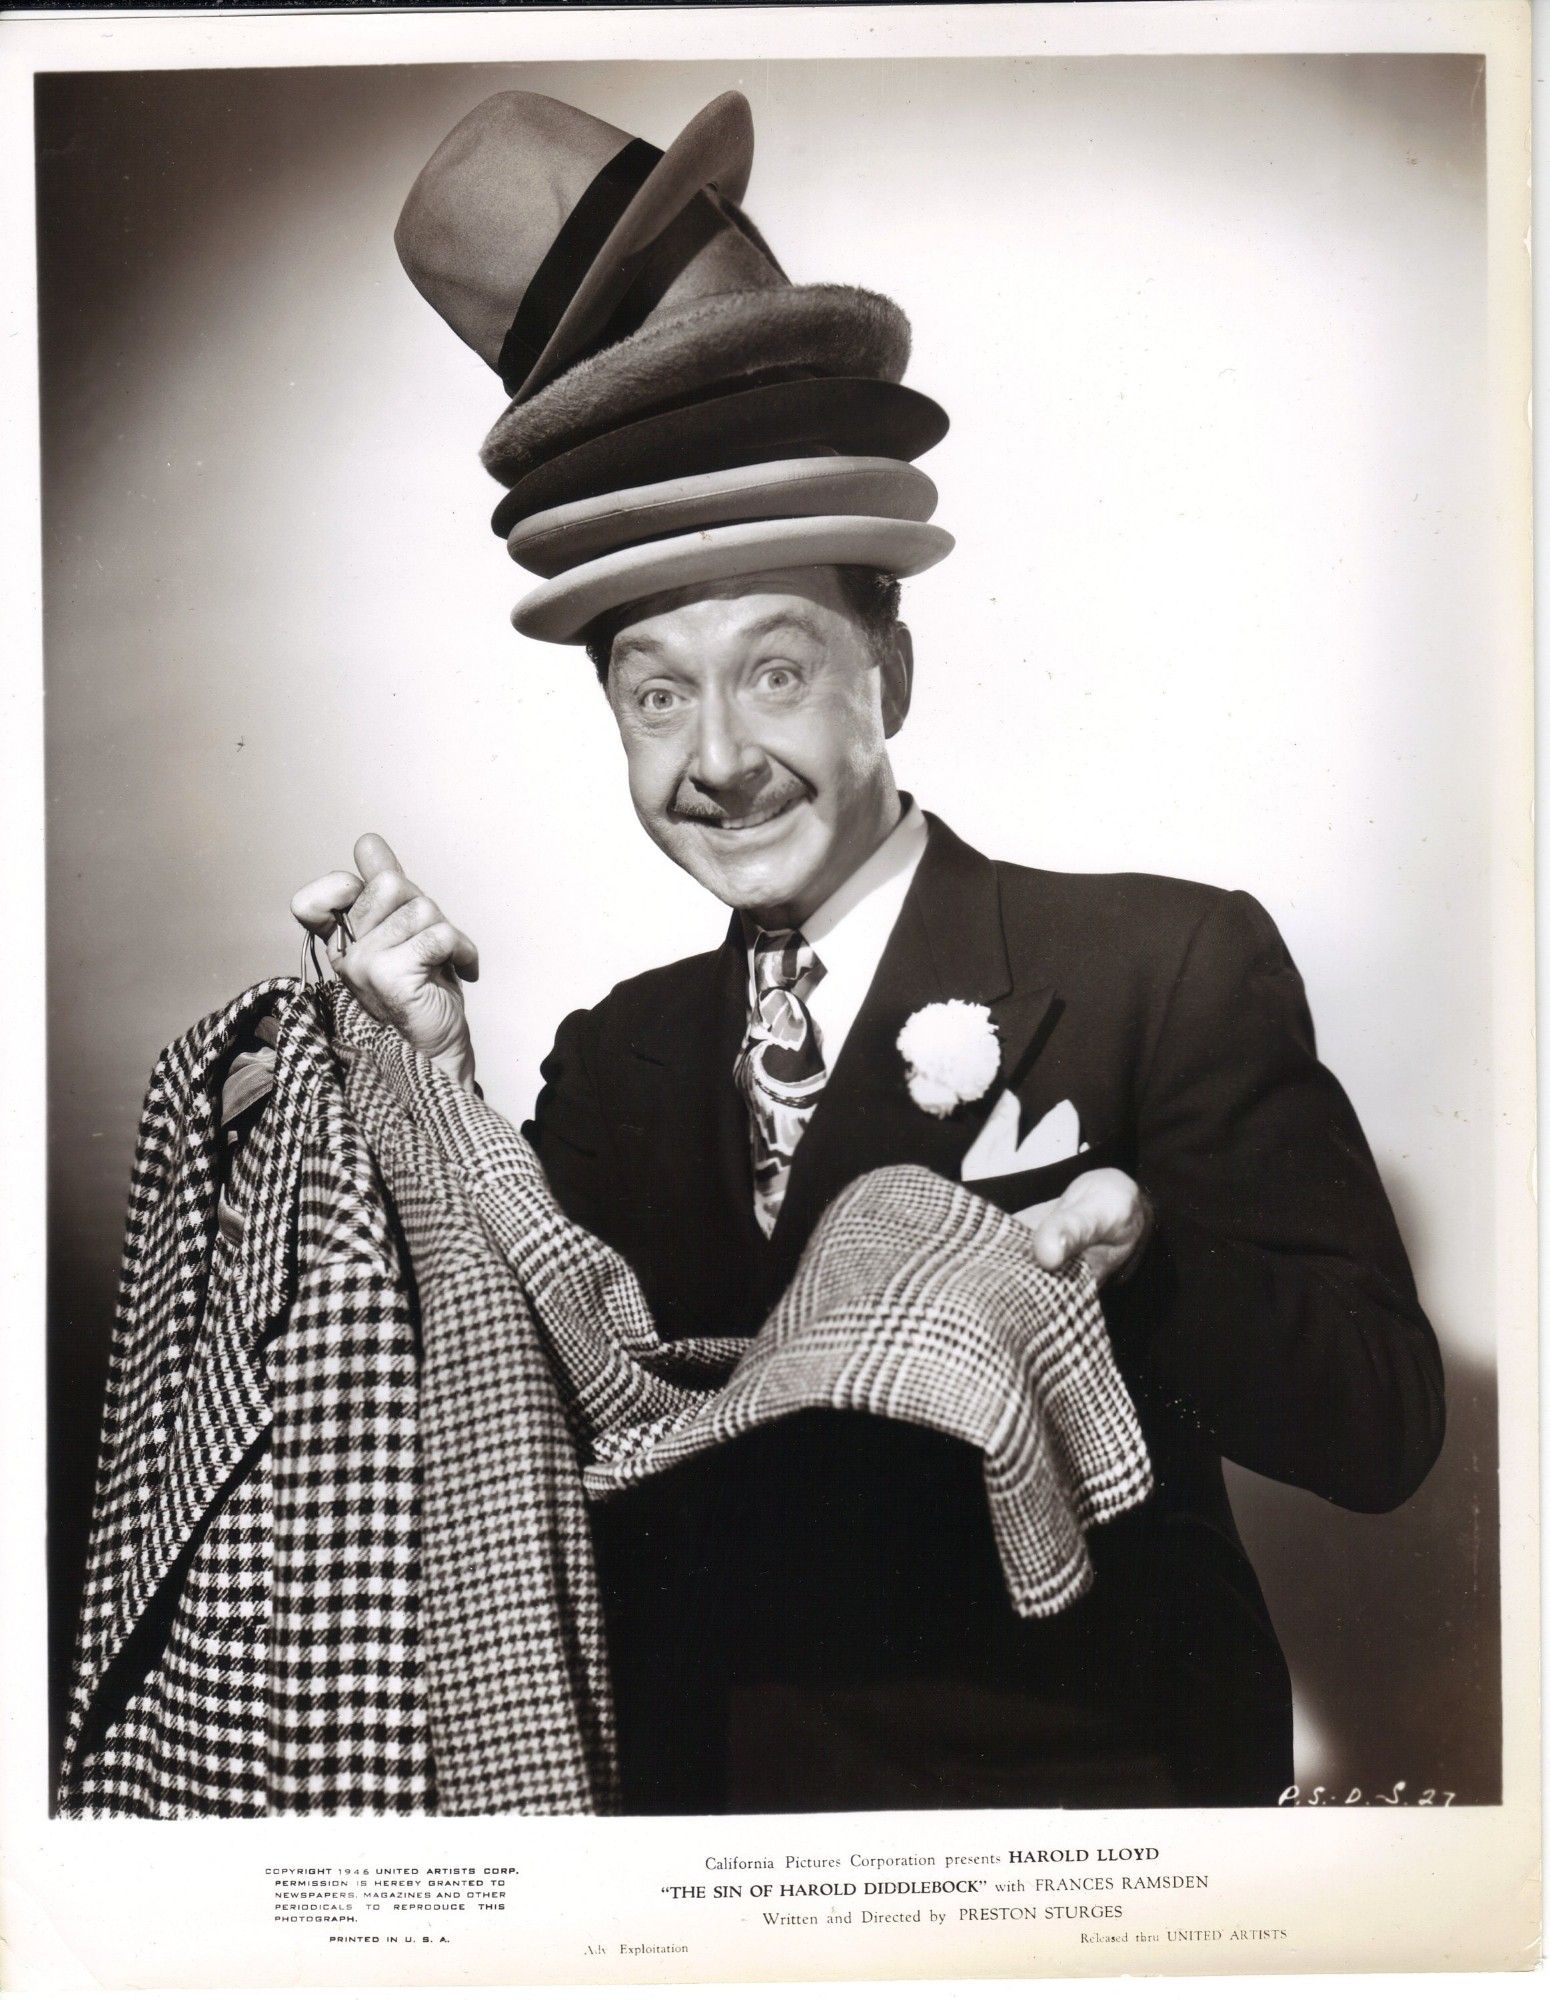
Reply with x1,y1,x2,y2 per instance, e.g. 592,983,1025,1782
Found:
528,818,1442,1812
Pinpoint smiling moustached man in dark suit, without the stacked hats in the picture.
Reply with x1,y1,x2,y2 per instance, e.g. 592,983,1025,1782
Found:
296,568,1442,1810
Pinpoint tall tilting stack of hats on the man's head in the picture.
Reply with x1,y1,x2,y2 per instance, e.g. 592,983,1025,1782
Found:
394,90,952,642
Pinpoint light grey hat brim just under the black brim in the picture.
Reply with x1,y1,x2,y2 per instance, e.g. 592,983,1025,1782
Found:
506,456,936,576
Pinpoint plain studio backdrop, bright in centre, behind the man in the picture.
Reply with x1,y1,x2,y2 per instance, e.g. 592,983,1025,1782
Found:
38,56,1500,1800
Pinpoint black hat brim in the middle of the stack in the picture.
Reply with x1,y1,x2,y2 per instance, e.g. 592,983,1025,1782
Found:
490,376,948,540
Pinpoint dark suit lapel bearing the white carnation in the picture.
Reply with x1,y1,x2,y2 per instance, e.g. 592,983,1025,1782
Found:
770,814,1056,1284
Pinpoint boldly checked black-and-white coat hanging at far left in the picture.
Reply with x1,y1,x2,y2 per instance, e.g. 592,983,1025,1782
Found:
60,980,434,1818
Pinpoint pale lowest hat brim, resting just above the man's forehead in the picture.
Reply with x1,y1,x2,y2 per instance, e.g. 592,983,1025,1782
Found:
512,514,952,644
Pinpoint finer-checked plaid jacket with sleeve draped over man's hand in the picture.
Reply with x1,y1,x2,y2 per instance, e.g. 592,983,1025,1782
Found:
324,990,1152,1810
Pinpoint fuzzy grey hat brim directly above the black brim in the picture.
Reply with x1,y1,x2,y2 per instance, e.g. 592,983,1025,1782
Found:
480,284,910,486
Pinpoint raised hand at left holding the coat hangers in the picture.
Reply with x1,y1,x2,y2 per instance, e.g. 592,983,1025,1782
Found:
290,834,478,1084
